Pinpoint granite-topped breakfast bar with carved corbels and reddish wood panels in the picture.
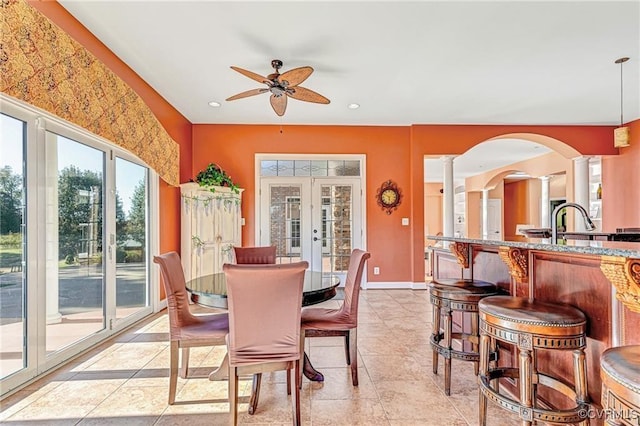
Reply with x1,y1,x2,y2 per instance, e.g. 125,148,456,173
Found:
427,236,640,412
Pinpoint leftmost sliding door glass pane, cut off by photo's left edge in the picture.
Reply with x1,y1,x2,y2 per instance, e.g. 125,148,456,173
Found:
0,114,27,378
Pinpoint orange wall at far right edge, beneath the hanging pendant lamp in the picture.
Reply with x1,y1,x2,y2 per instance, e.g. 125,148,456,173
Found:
602,120,640,232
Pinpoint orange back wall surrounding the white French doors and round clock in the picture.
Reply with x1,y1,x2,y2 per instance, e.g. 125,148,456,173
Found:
191,124,410,282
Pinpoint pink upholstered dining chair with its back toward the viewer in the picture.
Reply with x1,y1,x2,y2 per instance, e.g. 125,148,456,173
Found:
222,262,309,425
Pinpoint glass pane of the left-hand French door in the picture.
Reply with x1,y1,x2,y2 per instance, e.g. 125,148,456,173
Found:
269,185,302,263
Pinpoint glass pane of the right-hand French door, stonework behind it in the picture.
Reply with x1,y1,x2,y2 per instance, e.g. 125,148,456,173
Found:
320,184,353,273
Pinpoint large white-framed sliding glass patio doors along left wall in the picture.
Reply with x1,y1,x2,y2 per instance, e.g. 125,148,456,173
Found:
0,99,157,395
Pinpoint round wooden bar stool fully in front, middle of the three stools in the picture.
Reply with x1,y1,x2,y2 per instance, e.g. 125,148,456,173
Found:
478,296,589,425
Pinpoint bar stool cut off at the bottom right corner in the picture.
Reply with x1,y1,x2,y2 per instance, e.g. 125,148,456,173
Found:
600,345,640,426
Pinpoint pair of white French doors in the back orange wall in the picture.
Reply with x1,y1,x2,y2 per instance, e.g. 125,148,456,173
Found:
257,158,364,277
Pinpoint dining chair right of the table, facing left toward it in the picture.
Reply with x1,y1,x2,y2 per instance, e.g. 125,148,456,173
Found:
300,249,371,386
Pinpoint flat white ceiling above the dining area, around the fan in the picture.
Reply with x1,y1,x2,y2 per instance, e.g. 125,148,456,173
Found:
59,0,640,180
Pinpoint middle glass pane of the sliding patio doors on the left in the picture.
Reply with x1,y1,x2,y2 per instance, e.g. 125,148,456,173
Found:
46,132,105,355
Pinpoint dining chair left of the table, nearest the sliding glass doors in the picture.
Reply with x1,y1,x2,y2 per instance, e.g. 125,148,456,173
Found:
153,251,229,405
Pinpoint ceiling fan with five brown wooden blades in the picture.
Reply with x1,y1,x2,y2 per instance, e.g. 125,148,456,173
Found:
227,59,330,116
